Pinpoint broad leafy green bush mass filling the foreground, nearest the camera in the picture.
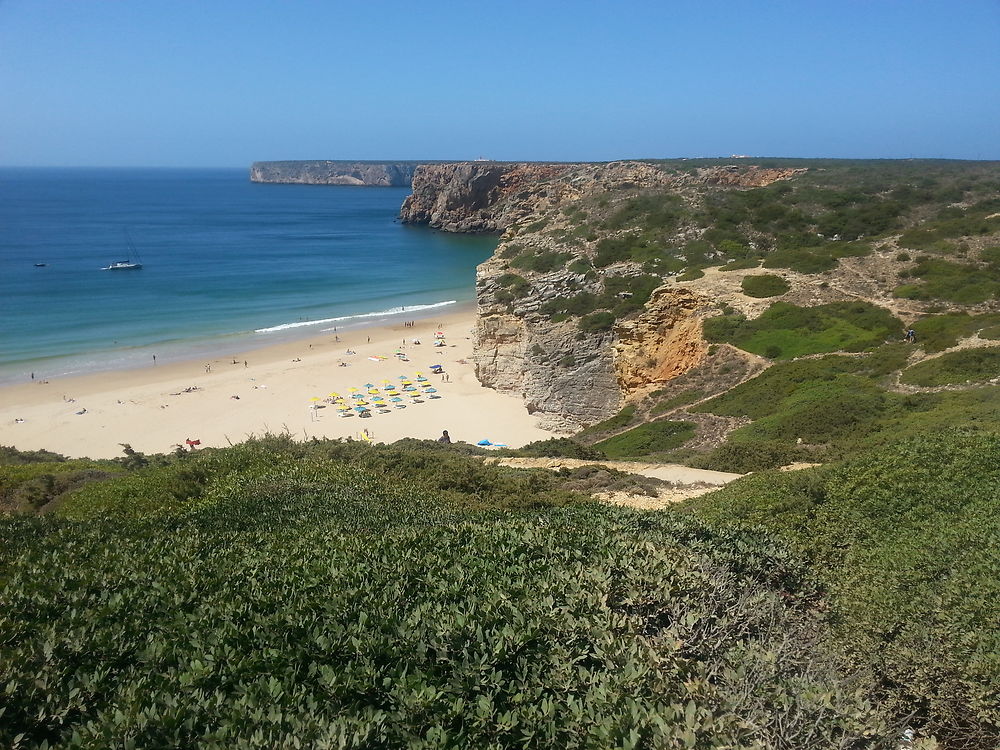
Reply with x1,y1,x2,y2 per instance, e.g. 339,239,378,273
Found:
0,445,896,749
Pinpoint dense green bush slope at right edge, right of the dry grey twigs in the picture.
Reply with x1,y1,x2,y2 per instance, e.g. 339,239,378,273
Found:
695,432,1000,748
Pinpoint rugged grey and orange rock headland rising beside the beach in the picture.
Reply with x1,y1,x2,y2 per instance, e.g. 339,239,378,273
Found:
400,162,802,432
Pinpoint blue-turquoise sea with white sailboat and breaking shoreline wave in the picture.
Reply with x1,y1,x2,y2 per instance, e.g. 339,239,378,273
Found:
0,169,496,382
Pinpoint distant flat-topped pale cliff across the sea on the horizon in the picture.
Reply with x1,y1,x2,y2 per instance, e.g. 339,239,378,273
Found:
250,161,419,187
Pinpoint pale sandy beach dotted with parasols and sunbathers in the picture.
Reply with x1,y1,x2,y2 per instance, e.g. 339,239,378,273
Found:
0,308,552,458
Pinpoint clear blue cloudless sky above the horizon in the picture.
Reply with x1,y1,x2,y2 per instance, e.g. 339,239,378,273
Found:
0,0,1000,166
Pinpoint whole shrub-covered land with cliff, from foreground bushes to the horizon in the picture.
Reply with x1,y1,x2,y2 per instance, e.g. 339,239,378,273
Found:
7,160,1000,750
